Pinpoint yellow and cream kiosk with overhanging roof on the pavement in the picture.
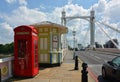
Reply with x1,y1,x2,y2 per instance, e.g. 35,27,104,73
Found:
34,21,68,65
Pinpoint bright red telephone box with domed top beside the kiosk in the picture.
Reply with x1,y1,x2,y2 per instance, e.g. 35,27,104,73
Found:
14,25,39,77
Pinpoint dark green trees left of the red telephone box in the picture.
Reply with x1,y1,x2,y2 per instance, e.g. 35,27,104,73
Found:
0,42,14,54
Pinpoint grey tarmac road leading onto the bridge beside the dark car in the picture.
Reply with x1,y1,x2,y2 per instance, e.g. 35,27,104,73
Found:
76,51,119,82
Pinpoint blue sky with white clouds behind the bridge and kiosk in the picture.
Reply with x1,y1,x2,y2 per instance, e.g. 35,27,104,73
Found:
0,0,120,45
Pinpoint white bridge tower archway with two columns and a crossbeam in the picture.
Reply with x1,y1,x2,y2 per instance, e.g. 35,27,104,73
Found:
61,10,95,49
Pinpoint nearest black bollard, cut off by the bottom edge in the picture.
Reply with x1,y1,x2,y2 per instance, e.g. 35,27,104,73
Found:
81,63,88,82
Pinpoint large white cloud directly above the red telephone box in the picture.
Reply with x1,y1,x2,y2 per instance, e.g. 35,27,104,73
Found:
4,6,46,26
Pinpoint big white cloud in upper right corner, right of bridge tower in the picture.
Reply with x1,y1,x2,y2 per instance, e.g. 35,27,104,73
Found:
93,0,120,23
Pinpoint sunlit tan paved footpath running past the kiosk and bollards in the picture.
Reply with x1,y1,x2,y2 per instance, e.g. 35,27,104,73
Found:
12,51,96,82
